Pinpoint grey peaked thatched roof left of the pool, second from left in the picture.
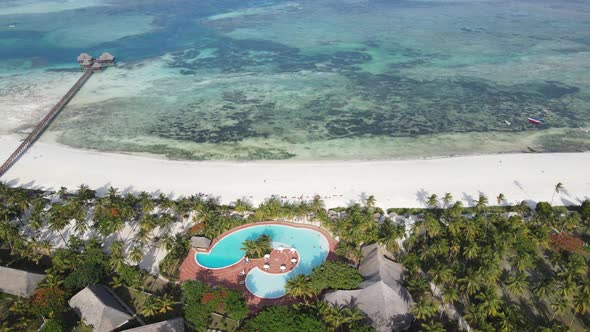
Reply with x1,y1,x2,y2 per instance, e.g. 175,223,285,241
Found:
69,284,131,332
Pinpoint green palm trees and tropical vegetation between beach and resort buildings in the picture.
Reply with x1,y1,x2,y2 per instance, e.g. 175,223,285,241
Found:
0,183,590,331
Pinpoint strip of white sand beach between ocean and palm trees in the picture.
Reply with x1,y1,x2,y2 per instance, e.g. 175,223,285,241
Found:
0,136,590,208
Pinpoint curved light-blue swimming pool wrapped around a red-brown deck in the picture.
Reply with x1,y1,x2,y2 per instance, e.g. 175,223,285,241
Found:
195,224,330,298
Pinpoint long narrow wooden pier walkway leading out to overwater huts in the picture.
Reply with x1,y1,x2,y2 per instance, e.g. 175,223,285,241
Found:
0,70,93,177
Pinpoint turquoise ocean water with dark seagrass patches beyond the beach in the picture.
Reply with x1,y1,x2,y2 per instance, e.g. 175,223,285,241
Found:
0,0,590,160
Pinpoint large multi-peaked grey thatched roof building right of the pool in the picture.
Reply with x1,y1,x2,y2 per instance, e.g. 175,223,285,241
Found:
324,244,412,332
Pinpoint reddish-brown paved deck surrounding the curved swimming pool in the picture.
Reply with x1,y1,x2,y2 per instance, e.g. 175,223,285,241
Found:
180,222,338,311
